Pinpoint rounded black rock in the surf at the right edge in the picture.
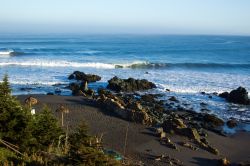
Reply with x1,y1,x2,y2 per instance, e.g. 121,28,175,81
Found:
227,87,250,105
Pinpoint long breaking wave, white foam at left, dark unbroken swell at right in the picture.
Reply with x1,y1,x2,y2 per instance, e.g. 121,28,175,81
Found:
0,60,250,69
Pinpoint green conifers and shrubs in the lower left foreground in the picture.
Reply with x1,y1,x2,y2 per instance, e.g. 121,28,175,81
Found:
0,75,120,165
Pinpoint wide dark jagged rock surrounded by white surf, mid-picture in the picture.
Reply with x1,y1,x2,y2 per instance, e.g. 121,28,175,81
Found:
107,76,156,92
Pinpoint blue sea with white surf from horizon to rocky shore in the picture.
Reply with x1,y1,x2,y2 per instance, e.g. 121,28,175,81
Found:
0,35,250,121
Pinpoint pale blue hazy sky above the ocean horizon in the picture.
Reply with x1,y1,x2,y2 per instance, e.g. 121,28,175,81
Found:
0,0,250,35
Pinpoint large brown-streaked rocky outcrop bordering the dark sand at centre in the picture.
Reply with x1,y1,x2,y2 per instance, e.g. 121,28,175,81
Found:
95,89,163,125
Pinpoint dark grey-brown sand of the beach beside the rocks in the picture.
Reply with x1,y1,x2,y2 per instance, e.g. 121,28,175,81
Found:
17,95,250,166
